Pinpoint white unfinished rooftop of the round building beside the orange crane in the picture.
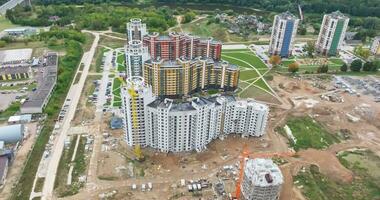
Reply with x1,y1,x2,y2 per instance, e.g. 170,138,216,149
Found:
244,158,284,187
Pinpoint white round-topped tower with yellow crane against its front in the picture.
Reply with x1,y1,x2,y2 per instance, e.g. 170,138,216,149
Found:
121,76,155,147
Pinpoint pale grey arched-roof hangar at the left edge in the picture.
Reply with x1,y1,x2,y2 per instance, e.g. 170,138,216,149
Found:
0,124,25,143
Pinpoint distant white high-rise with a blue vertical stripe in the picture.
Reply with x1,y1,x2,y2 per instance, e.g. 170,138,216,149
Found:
269,12,300,57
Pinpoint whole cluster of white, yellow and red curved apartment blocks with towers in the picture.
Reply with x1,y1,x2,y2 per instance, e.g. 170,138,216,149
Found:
121,20,269,152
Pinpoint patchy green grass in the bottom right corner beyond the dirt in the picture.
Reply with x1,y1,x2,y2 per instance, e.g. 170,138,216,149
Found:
294,150,380,200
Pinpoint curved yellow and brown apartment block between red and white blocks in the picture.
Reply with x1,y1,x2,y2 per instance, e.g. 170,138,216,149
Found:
144,58,239,97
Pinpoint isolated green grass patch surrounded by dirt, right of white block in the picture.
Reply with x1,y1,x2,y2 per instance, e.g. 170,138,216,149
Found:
281,116,339,151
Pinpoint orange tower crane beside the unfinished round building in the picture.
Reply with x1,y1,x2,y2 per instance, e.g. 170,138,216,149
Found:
232,145,295,200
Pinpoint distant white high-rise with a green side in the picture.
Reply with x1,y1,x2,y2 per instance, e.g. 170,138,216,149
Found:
316,11,350,56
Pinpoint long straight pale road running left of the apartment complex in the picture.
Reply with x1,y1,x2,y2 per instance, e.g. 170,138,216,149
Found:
42,32,99,200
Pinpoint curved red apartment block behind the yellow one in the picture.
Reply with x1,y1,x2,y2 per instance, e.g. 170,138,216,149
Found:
144,32,222,60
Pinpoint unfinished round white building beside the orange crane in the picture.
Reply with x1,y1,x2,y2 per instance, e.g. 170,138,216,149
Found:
240,158,284,200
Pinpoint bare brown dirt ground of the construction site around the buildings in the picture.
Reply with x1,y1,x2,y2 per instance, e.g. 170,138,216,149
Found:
60,75,380,200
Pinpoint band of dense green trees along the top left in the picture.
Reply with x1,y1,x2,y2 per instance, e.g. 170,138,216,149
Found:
6,4,176,32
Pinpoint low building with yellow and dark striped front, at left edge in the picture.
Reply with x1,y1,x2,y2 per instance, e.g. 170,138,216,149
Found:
0,65,33,81
